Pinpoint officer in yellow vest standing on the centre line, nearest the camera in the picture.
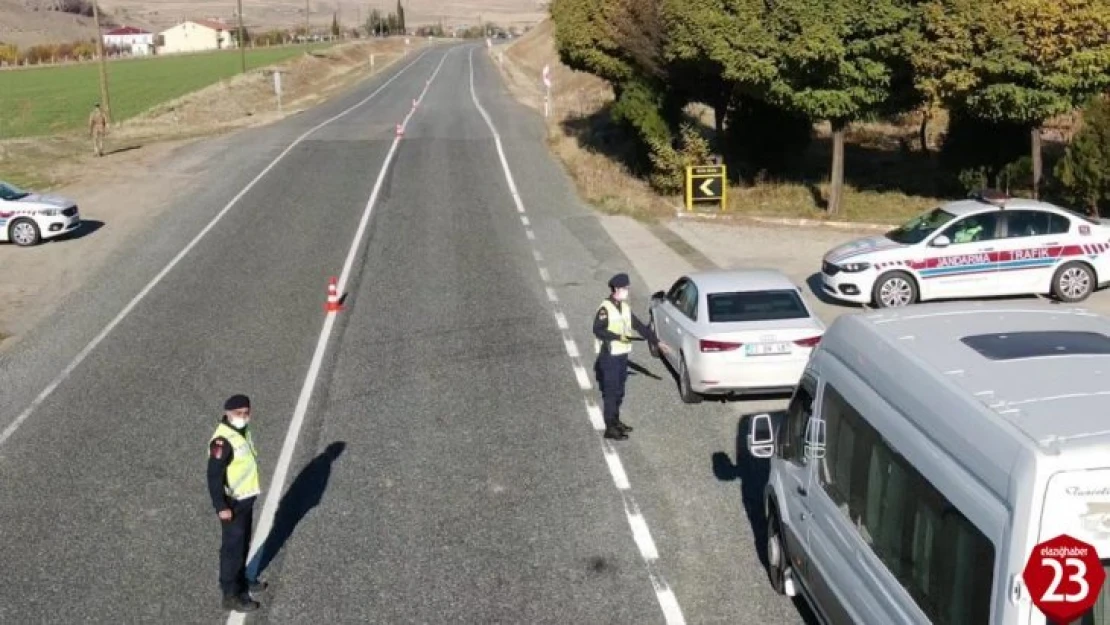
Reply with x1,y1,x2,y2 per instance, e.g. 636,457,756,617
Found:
208,395,266,612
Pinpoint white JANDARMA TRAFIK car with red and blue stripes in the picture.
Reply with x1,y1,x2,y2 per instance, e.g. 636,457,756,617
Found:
821,192,1110,308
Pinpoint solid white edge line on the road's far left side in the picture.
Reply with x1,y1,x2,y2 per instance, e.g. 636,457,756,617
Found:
0,50,431,445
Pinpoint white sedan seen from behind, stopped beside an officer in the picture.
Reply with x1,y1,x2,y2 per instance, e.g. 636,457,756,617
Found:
648,269,825,404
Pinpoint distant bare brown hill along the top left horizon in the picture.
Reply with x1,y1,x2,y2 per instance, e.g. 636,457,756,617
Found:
0,0,547,48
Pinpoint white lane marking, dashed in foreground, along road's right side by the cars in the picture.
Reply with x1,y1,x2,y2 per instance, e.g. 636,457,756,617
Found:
470,48,686,625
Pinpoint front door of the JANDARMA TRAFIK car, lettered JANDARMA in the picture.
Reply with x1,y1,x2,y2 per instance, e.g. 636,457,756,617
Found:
919,211,1006,299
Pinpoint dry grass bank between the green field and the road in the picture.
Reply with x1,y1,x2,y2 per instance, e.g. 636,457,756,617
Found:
0,40,425,190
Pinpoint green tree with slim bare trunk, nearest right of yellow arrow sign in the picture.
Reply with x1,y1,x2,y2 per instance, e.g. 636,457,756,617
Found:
764,0,914,214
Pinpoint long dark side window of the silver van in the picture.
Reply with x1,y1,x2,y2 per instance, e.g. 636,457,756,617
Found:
818,384,995,625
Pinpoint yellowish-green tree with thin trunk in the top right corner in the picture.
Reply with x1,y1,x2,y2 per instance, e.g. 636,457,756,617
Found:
915,0,1110,195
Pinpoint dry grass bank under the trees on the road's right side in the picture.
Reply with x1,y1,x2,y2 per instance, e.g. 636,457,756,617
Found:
493,20,1072,223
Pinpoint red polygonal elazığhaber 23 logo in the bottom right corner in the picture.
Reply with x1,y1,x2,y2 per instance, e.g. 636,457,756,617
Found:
1021,534,1107,625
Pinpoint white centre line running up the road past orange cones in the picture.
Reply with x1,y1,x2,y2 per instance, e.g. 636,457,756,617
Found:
228,50,454,625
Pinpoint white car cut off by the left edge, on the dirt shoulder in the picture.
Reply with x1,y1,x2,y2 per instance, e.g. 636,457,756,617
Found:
0,181,81,246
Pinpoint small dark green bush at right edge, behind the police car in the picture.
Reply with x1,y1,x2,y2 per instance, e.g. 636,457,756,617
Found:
1056,95,1110,215
